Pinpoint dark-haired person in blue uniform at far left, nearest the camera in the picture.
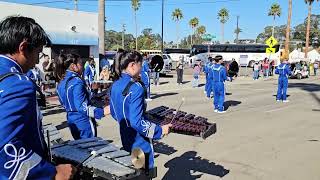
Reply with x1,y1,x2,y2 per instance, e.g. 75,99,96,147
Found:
0,16,75,180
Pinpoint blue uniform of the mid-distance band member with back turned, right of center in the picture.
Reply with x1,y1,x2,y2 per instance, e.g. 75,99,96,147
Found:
211,64,232,112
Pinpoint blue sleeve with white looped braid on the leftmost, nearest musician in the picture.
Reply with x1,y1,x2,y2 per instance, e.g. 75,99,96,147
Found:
0,80,56,179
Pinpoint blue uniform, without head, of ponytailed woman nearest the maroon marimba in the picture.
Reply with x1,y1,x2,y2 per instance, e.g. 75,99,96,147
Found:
110,73,162,169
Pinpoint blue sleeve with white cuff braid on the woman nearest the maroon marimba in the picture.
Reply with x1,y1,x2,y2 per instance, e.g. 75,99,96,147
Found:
128,85,162,140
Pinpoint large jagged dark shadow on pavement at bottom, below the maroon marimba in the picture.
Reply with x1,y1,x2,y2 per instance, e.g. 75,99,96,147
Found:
162,151,229,180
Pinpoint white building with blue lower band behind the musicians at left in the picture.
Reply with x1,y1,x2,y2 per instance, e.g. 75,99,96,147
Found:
0,2,99,75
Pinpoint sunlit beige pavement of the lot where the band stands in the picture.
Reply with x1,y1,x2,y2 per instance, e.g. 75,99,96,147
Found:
44,73,320,180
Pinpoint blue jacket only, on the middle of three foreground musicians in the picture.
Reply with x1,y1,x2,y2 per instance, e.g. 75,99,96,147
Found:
57,70,104,123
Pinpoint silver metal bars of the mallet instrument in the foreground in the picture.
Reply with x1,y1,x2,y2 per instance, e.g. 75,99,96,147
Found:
52,138,139,179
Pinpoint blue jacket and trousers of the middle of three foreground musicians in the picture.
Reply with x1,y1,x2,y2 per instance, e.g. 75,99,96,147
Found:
57,70,104,139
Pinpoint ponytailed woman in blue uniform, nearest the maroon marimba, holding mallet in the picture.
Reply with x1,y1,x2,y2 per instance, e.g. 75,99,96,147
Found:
110,52,172,177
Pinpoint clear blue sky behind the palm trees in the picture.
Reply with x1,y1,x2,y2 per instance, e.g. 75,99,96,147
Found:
2,0,320,41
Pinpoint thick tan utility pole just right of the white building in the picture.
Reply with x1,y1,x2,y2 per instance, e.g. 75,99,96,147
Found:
98,0,106,54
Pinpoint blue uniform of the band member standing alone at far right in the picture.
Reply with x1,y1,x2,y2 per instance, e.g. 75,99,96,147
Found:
275,63,291,100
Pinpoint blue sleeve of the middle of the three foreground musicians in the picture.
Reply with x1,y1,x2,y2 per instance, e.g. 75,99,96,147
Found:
71,83,104,119
